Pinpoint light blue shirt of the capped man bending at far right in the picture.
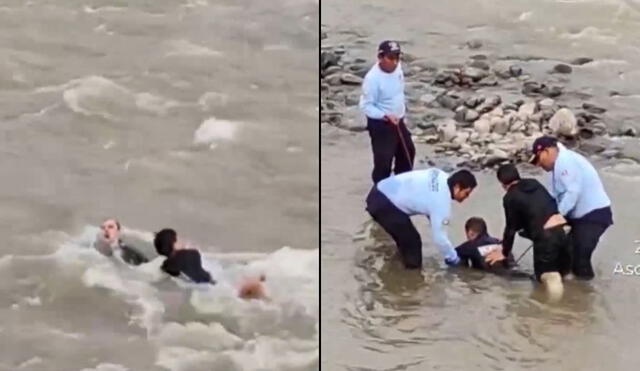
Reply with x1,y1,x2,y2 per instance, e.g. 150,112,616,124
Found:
551,143,611,219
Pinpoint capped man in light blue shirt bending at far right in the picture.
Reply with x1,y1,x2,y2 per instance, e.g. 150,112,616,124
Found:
530,136,613,280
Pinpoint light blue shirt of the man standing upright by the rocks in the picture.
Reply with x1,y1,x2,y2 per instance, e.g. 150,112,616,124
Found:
360,63,405,120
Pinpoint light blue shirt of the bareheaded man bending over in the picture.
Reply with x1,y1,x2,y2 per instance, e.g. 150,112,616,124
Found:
377,168,459,262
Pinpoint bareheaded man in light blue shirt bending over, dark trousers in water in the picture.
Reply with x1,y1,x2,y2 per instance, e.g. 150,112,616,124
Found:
367,168,477,269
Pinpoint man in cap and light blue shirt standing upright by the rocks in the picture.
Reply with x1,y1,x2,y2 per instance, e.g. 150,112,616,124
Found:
360,41,415,183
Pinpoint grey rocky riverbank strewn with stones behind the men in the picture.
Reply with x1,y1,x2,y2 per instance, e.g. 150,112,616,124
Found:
320,31,637,169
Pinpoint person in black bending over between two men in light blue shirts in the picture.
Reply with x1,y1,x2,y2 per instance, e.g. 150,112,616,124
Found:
487,164,571,296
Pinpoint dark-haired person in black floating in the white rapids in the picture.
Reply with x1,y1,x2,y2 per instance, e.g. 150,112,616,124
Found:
153,228,266,299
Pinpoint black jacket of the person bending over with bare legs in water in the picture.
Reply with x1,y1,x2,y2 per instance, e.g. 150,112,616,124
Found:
502,179,558,256
